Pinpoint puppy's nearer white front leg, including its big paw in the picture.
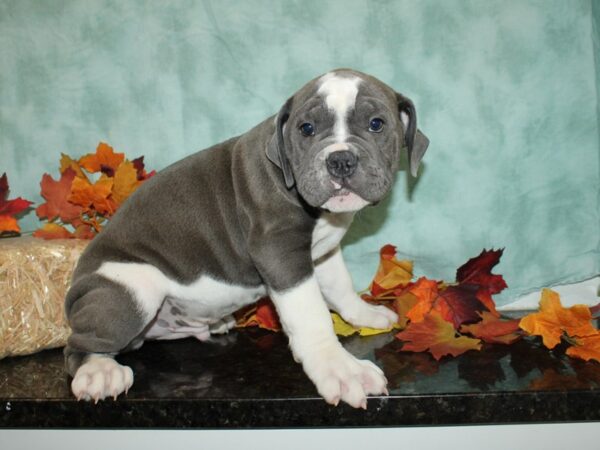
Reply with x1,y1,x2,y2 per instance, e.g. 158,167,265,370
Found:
271,276,387,408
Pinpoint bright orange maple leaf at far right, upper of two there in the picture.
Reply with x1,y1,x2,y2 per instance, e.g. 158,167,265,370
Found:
519,289,598,349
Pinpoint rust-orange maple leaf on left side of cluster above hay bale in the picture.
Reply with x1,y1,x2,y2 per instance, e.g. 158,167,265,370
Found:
35,167,83,225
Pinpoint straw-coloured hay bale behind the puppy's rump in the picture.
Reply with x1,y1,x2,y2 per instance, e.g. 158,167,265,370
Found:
0,236,89,358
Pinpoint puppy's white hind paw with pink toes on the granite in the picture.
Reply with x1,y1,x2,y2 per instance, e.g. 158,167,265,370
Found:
71,355,133,403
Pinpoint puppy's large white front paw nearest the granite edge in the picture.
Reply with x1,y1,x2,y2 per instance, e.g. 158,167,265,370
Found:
303,345,388,409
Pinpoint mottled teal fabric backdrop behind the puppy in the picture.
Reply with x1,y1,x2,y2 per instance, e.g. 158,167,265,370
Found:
0,0,600,303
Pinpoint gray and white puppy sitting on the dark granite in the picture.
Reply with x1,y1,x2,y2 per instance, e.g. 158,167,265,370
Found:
65,69,428,408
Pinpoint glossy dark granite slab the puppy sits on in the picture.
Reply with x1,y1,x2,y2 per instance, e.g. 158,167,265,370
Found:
0,330,600,428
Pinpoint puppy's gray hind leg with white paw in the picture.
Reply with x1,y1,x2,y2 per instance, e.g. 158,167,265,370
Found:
64,273,162,401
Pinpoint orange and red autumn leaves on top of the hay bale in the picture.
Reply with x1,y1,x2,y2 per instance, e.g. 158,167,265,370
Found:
0,142,155,239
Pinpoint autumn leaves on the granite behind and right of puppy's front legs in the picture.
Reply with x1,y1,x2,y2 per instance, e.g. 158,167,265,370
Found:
236,245,600,362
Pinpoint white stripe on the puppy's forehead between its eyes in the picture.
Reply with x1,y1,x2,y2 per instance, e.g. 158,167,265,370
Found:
317,73,362,142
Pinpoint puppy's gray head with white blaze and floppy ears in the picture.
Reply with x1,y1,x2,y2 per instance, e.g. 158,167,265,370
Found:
267,69,429,212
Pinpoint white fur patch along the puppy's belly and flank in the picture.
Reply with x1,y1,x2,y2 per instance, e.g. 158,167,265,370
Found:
97,262,267,339
